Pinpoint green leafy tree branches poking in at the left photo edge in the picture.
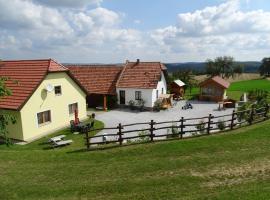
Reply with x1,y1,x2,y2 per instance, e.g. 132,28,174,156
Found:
0,77,16,146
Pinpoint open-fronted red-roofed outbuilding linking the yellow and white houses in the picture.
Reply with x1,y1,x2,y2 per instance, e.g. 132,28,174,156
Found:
66,65,123,110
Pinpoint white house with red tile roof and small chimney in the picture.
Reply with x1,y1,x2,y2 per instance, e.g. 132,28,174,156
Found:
116,60,167,108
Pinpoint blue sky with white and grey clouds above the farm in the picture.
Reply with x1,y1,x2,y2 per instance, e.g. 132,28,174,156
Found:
0,0,270,63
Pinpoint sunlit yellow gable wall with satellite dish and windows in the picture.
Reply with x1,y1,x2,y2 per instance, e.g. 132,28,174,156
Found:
20,72,87,141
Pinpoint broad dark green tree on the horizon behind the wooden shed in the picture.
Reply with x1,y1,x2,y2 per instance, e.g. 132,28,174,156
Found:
206,56,243,78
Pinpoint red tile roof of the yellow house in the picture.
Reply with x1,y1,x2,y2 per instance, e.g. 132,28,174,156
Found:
0,59,68,110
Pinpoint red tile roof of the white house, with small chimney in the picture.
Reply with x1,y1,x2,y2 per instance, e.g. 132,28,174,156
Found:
116,61,166,89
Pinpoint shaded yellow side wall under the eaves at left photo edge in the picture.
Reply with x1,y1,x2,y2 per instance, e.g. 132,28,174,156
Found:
0,110,23,140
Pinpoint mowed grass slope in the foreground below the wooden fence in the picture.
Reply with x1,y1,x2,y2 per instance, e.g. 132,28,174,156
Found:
0,121,270,200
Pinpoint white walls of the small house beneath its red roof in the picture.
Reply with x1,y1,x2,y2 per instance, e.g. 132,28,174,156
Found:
116,72,167,108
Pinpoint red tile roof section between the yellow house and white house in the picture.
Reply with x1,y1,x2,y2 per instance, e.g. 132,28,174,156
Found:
67,65,123,95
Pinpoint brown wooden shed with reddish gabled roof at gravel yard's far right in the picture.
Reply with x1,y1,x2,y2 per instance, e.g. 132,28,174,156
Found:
199,76,230,102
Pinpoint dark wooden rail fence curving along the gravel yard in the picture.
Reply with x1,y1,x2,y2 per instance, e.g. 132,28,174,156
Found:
85,105,269,150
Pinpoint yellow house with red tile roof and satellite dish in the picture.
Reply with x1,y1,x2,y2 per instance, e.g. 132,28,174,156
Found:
0,59,87,141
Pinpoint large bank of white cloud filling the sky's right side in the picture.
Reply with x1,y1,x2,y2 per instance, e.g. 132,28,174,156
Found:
151,0,270,60
